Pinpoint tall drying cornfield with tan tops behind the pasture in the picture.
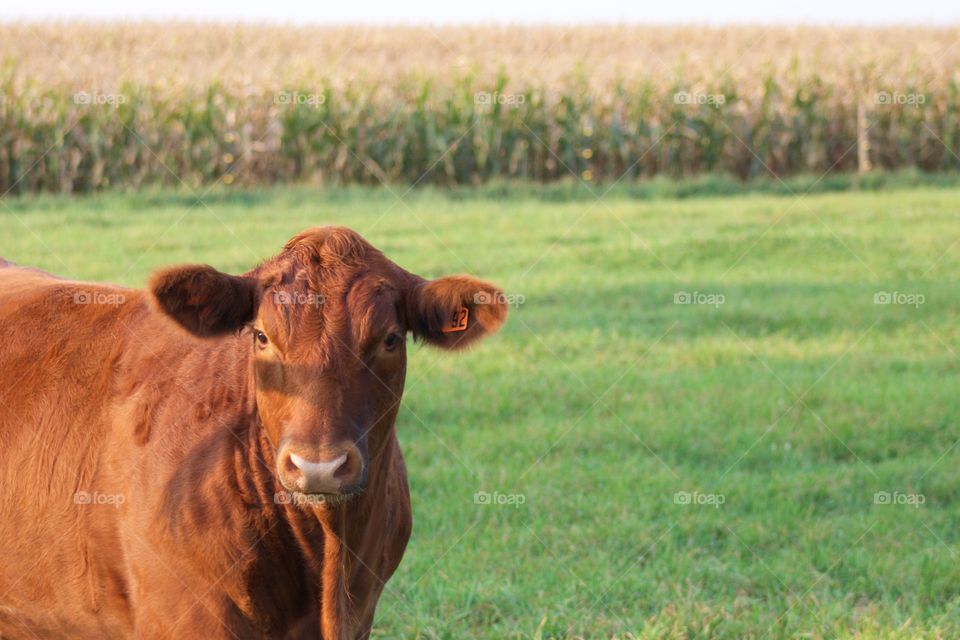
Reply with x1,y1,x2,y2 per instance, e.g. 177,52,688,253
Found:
0,22,960,194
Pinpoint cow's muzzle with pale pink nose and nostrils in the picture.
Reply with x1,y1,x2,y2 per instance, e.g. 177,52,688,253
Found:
277,443,364,496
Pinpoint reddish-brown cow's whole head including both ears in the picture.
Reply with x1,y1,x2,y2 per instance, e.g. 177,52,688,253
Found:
150,228,506,500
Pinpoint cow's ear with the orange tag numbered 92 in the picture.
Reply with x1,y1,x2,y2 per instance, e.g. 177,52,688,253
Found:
406,276,507,349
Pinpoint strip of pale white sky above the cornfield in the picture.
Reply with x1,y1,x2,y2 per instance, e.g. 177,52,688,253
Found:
0,0,960,25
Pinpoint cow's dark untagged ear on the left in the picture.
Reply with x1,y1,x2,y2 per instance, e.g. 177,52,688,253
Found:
149,265,260,336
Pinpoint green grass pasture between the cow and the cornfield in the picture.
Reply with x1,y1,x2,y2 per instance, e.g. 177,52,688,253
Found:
0,182,960,639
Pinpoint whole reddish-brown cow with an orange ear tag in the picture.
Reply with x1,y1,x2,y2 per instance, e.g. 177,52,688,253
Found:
0,228,506,640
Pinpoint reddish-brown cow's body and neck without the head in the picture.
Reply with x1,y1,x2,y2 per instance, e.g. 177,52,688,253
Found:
0,229,510,639
